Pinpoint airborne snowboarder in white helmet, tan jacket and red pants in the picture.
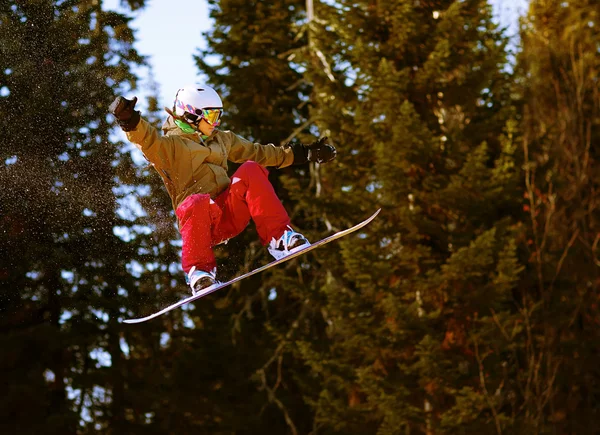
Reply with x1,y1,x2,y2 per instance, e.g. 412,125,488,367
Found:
109,85,336,295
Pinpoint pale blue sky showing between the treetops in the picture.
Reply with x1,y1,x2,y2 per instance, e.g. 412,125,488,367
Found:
103,0,527,112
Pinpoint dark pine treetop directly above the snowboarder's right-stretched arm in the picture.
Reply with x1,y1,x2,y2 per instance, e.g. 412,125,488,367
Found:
195,0,307,144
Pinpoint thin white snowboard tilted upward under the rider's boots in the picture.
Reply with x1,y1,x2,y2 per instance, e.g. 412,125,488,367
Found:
123,209,381,323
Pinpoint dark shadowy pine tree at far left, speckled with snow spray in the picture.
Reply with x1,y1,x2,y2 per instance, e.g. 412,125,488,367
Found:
0,0,150,433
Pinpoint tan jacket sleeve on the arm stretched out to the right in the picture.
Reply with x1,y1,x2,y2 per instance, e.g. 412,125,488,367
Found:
224,131,294,168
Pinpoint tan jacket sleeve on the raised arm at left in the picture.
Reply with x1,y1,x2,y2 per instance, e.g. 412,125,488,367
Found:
126,118,178,169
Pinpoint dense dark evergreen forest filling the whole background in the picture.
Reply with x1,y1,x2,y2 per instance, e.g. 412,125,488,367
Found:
0,0,600,435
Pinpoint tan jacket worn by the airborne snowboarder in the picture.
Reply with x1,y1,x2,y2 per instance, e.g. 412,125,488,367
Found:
127,116,294,210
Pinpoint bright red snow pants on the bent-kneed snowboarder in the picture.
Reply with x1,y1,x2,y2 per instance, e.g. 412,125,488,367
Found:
176,161,290,273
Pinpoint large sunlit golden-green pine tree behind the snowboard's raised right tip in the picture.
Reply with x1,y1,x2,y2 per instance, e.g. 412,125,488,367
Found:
282,1,521,433
